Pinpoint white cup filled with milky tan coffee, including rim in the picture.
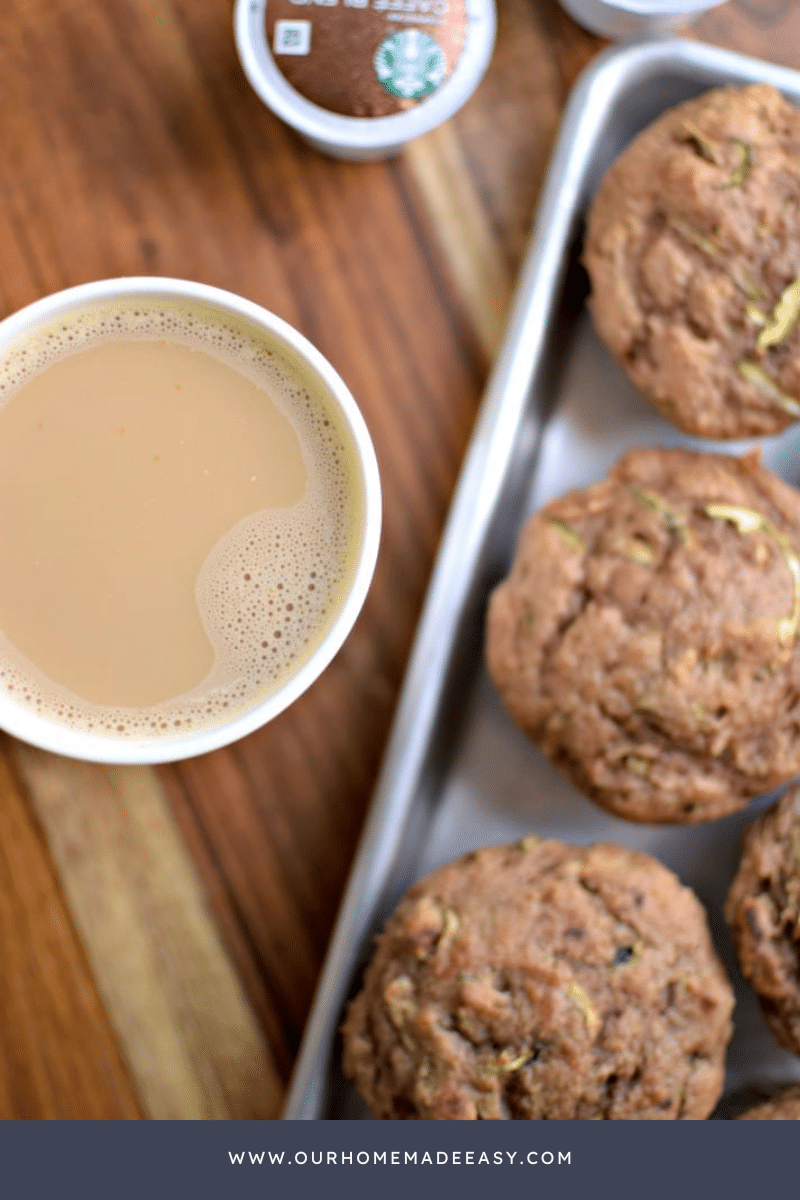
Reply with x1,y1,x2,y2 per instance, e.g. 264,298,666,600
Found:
0,278,380,762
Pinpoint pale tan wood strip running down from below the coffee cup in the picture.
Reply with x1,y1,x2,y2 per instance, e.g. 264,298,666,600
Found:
13,743,281,1120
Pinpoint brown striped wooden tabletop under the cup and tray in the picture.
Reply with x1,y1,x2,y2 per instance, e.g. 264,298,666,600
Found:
0,0,800,1118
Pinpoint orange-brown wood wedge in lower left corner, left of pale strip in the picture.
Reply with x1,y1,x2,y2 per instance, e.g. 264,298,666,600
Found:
0,737,142,1120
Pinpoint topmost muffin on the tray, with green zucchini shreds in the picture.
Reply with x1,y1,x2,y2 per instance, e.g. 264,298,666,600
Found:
584,84,800,438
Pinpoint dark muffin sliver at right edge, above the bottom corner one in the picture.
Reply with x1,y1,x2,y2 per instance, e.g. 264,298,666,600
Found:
724,787,800,1054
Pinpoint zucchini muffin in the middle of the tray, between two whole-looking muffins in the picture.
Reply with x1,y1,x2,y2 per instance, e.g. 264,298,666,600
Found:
487,449,800,822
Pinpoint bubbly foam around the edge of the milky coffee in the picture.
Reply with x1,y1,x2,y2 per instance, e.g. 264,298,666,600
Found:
0,298,363,740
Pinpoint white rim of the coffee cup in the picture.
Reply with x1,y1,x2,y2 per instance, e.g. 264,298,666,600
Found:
0,275,383,766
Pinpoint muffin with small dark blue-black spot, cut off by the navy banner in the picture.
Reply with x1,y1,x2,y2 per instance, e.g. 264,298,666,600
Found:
342,836,733,1121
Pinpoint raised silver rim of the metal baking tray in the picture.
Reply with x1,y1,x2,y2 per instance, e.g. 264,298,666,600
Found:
282,37,800,1121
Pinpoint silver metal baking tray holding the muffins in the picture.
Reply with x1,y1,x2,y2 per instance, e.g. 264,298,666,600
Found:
284,40,800,1120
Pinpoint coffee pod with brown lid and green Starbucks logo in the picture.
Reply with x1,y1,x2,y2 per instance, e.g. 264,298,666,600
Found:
234,0,497,158
